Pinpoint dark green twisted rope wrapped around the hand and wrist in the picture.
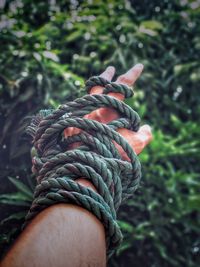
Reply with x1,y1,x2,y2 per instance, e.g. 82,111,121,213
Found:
25,76,141,255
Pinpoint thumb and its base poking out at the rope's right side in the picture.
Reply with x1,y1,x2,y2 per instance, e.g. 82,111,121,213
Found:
115,124,153,161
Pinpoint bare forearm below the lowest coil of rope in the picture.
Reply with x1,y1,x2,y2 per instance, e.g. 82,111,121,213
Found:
1,204,106,267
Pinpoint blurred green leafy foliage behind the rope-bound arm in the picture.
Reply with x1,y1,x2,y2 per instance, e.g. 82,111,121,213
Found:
0,0,200,267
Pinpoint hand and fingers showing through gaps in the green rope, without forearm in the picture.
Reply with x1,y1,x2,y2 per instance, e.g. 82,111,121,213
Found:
64,64,152,191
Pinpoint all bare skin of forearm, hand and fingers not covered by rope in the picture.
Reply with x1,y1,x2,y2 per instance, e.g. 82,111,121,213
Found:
0,64,152,267
